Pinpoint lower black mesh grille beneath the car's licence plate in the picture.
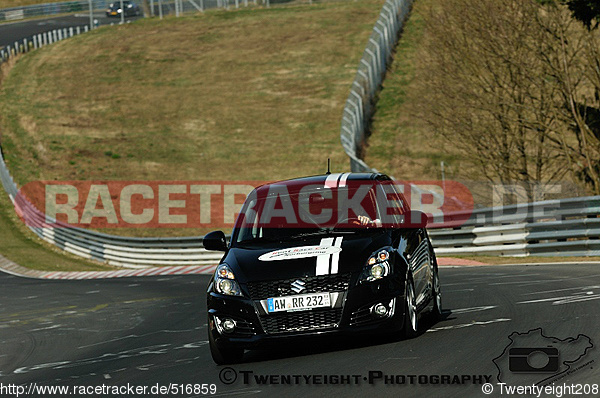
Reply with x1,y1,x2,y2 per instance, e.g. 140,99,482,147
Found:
260,308,342,334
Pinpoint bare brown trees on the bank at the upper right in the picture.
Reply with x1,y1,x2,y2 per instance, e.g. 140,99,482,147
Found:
415,0,600,197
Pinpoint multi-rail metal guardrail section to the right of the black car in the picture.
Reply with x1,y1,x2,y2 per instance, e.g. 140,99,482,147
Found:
429,196,600,256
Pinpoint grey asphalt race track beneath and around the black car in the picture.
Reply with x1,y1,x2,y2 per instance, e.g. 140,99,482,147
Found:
0,264,600,397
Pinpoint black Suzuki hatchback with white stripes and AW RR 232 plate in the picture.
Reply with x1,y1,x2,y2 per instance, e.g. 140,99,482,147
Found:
203,173,442,364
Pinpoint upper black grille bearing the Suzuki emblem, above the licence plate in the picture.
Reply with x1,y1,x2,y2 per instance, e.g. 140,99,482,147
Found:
248,273,350,300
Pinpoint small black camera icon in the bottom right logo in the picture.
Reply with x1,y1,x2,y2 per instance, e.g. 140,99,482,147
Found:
508,346,559,373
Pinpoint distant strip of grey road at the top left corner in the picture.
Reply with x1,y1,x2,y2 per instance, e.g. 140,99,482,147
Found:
0,12,141,48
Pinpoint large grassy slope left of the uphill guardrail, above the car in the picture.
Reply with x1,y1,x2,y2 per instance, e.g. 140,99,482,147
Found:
0,0,382,184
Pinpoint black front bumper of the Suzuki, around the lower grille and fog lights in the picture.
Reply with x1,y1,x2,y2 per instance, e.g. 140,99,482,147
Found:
207,276,404,348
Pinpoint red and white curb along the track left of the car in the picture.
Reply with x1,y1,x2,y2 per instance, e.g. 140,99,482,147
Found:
0,255,217,280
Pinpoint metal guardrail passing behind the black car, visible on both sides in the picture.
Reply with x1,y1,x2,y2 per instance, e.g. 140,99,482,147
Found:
0,143,600,267
